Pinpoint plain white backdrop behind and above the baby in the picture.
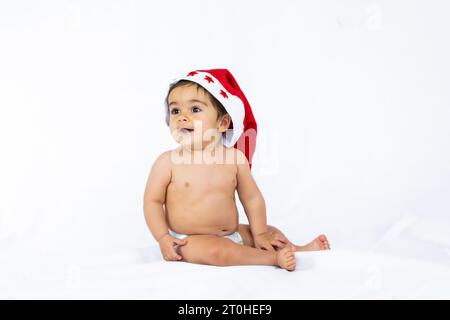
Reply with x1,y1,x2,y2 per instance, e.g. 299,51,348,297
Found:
0,0,450,298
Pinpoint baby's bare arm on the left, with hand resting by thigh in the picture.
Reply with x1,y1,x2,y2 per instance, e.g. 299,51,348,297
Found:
144,151,186,260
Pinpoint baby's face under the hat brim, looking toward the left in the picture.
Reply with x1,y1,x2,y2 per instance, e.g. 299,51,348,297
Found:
168,85,226,149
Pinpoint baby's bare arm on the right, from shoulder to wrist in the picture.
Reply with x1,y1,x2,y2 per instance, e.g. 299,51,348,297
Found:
236,150,273,250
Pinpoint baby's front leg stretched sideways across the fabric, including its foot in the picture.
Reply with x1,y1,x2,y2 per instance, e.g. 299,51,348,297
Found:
179,235,295,270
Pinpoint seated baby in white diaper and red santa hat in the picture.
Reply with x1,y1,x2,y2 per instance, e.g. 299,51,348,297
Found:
144,69,330,271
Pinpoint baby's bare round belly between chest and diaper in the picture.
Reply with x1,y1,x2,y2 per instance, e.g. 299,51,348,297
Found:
166,197,239,236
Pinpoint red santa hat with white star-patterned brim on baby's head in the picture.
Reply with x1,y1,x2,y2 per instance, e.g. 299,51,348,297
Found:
166,69,257,169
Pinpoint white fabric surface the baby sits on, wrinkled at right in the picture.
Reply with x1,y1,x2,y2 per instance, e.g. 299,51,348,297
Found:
0,215,450,299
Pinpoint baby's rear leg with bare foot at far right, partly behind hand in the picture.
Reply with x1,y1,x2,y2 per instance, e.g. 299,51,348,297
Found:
238,224,330,251
